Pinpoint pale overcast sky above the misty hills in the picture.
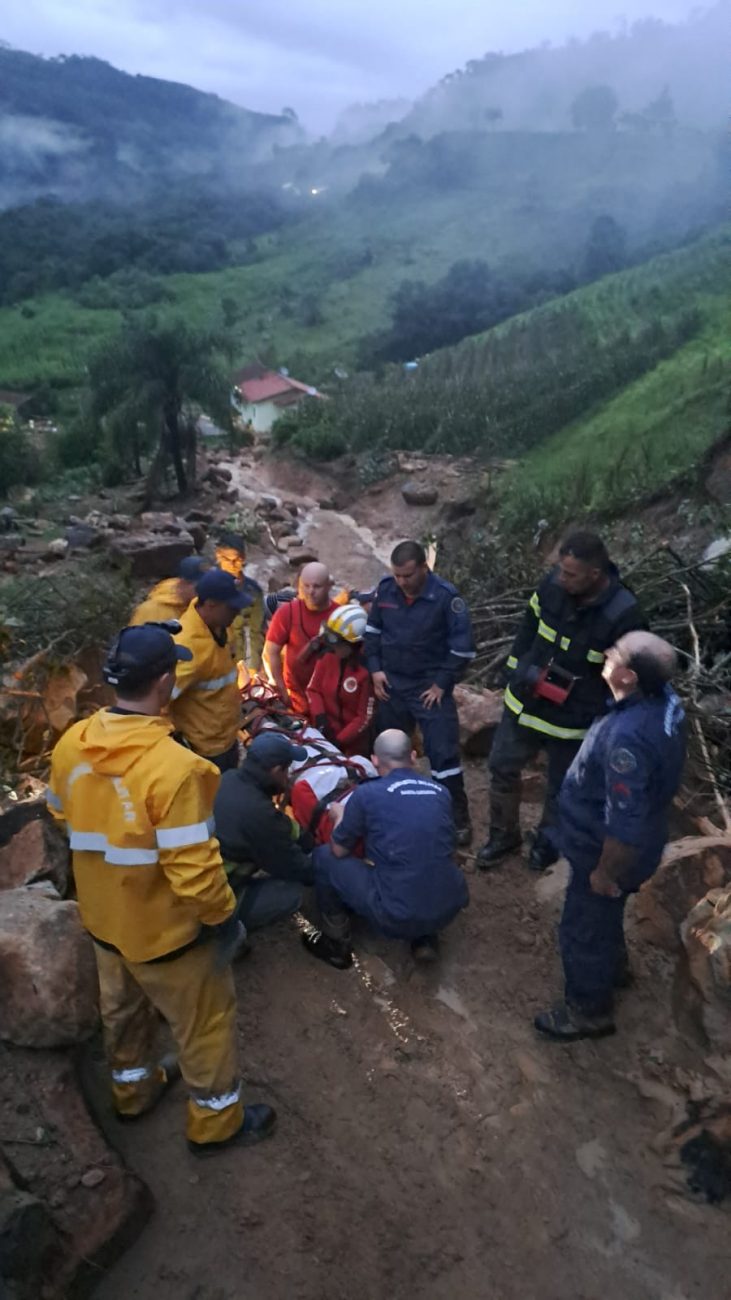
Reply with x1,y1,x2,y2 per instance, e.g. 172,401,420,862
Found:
0,0,693,131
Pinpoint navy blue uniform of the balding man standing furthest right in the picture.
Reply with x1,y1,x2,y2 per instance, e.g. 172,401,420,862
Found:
559,688,685,1015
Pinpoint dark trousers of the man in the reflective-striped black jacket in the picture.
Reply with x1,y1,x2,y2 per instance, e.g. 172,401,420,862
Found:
488,709,581,853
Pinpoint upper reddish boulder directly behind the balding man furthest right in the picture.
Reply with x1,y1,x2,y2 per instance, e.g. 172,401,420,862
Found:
635,835,731,953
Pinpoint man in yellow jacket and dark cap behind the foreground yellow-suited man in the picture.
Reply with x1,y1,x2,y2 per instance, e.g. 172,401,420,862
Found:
170,569,248,772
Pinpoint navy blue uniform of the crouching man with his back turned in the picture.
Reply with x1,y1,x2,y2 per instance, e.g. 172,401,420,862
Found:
313,767,468,940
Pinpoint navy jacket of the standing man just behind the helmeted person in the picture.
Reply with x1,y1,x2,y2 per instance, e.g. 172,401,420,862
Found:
364,573,475,692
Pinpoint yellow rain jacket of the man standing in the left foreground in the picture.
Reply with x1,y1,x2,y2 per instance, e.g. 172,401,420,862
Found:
47,709,234,962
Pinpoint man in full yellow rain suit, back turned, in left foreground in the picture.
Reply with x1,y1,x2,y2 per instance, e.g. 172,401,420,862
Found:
48,624,274,1154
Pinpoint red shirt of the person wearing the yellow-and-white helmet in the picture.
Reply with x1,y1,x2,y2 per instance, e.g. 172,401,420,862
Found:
307,654,371,758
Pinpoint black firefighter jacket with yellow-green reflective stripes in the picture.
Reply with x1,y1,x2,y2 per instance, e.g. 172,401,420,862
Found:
505,566,646,741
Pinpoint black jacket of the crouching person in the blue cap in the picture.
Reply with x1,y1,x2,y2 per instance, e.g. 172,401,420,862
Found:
213,757,312,885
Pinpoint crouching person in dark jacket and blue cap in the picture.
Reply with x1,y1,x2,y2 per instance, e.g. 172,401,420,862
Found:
213,731,315,931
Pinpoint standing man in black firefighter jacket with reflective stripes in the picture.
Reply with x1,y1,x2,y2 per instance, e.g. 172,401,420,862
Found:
477,533,645,871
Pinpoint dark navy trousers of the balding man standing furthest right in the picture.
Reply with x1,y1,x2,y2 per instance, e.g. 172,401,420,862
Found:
558,861,630,1015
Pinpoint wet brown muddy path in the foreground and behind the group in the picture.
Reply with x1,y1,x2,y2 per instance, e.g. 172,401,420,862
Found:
95,463,731,1300
